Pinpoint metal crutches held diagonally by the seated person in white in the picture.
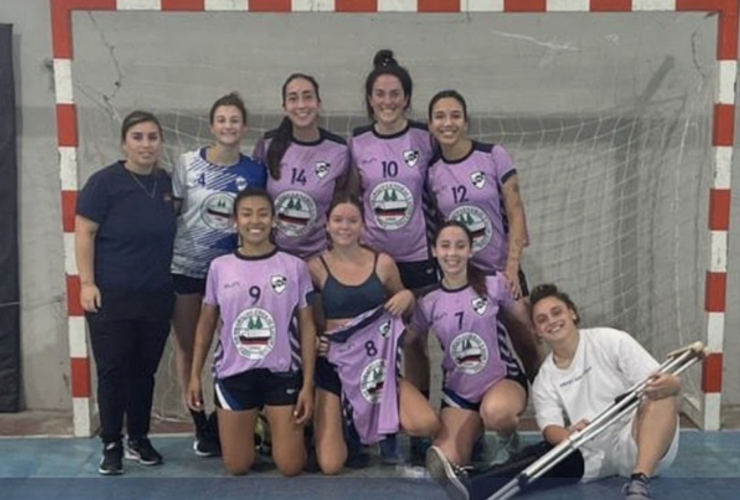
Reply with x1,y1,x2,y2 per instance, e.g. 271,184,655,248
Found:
488,342,706,500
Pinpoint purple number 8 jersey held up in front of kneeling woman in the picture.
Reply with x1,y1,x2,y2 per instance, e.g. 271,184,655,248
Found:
327,306,404,444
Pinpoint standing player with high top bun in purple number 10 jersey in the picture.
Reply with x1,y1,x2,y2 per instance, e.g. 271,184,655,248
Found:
350,50,437,461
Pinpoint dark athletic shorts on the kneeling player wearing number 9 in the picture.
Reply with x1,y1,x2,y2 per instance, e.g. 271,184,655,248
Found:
214,368,303,411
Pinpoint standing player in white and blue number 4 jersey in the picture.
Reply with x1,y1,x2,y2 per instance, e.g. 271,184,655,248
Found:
172,93,267,456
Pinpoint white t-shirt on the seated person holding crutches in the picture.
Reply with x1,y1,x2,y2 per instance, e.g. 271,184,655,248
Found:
532,328,659,478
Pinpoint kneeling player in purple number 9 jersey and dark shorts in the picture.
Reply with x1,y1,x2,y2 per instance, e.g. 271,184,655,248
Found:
188,188,316,476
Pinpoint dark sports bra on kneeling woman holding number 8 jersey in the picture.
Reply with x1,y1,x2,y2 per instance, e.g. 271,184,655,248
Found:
319,253,385,319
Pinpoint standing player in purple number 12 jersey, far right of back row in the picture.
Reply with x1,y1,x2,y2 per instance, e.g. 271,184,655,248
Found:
428,90,542,380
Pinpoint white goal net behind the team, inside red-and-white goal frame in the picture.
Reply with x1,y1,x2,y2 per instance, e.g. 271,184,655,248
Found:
73,11,717,426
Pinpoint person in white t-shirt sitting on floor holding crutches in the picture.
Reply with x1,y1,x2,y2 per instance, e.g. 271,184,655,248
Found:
427,285,681,500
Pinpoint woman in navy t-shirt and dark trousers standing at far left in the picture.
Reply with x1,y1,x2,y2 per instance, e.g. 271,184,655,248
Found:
75,111,175,475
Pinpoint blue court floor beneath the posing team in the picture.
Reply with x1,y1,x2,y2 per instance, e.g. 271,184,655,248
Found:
0,430,740,500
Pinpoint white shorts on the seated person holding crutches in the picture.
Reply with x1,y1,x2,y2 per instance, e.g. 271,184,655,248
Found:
582,415,680,481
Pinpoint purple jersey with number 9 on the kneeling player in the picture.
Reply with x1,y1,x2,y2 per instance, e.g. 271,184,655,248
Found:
203,248,313,378
